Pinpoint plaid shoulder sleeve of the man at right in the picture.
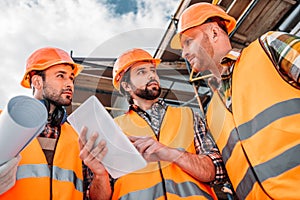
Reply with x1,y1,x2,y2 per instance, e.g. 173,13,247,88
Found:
260,31,300,85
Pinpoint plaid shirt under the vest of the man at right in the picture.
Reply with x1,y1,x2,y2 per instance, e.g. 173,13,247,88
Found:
219,32,300,111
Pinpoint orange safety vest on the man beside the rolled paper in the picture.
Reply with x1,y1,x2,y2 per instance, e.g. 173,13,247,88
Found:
0,123,83,200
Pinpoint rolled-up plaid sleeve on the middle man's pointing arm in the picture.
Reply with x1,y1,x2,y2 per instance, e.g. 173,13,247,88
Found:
194,113,226,184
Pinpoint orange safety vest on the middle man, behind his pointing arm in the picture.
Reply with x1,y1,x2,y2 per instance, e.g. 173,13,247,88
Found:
113,106,217,200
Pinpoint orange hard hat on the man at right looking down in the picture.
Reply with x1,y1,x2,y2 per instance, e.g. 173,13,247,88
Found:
171,2,236,49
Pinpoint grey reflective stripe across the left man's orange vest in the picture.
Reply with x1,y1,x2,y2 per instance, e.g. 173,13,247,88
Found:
17,164,83,192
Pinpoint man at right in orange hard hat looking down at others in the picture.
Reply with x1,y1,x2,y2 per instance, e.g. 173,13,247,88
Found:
171,3,300,199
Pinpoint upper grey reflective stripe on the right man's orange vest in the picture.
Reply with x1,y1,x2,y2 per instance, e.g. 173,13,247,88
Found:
222,98,300,164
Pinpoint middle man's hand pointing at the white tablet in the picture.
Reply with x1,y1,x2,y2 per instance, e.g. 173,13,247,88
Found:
128,136,173,162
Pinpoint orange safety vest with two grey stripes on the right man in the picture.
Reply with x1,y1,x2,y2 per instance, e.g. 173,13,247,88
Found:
207,40,300,199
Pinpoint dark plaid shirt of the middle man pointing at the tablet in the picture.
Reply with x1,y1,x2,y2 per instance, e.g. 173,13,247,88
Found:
129,100,226,184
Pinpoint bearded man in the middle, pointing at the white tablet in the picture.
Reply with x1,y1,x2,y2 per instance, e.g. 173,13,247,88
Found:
84,49,225,200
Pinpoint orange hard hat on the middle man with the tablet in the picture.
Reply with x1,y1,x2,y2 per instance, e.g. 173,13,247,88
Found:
113,49,160,90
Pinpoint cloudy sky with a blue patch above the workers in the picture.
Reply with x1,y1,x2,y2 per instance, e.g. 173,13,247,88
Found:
0,0,180,109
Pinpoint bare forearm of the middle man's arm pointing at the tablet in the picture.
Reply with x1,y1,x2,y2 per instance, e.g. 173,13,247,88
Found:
171,149,215,182
